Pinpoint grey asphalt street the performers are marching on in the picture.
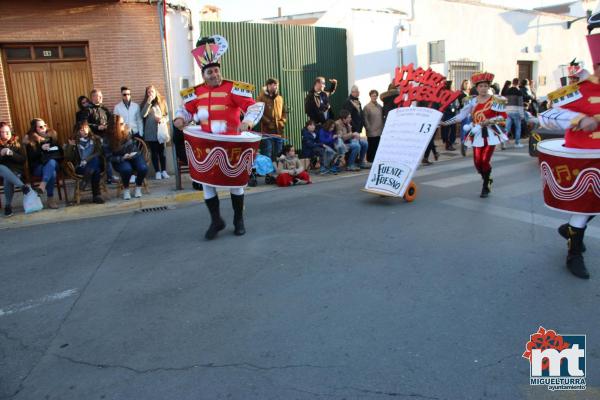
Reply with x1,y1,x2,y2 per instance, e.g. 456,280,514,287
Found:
0,149,600,400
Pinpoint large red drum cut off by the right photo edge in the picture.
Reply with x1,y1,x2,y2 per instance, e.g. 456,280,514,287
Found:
537,139,600,215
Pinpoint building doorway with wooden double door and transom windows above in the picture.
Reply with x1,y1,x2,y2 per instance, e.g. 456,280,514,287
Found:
2,43,92,143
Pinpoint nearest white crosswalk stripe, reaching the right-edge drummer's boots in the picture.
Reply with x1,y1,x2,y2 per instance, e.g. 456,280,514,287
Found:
442,197,600,239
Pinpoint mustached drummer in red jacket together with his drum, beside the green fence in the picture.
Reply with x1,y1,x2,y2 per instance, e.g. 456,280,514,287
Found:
173,35,264,240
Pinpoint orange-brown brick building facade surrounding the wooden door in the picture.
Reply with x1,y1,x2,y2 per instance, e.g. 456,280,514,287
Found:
0,0,165,135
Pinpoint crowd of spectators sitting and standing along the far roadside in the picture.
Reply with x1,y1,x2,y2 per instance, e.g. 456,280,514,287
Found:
0,72,539,216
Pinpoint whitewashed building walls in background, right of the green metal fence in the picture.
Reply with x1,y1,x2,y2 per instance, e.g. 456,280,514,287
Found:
316,0,591,104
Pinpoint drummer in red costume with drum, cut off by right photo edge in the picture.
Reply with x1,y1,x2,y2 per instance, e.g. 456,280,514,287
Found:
538,14,600,279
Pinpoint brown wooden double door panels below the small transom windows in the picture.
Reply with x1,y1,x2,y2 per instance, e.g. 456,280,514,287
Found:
8,61,92,143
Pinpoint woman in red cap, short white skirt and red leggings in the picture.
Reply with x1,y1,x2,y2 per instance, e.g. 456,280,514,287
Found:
441,72,508,197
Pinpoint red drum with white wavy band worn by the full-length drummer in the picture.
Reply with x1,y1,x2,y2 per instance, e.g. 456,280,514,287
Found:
183,126,261,188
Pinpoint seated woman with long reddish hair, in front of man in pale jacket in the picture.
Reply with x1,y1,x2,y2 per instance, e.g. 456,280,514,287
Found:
109,115,148,200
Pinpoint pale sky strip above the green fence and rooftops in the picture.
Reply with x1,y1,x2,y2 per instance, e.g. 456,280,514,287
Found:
211,0,584,21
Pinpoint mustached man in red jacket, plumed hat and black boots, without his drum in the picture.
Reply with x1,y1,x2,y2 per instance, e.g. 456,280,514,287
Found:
173,35,264,240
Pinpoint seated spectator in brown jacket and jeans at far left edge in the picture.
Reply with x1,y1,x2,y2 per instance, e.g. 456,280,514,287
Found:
0,122,30,217
